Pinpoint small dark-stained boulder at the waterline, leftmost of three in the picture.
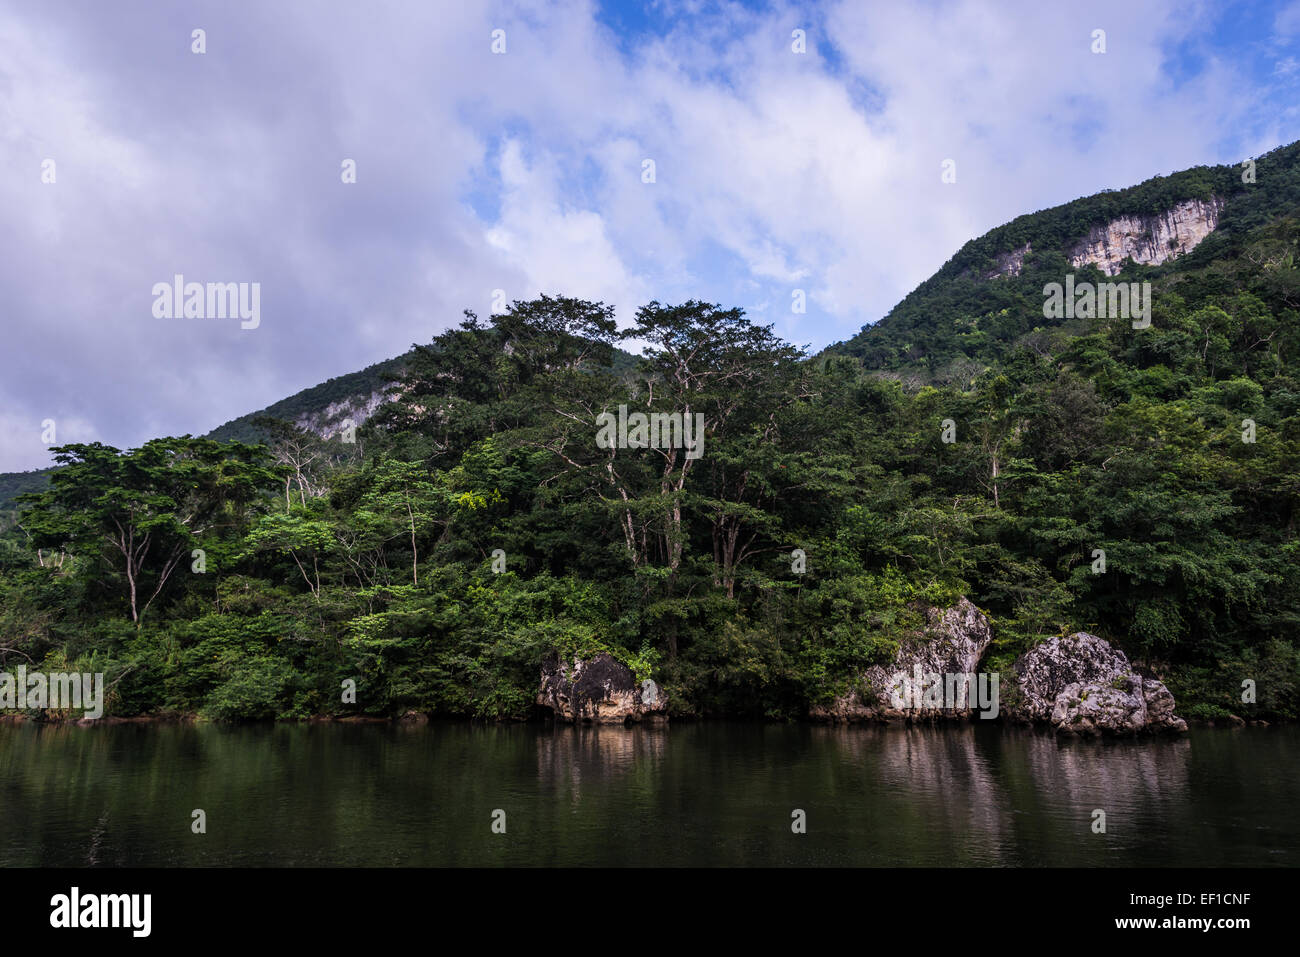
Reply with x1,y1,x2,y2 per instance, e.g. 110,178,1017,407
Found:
537,651,668,724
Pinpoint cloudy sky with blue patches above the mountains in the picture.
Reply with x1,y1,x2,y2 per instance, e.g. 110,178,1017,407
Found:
0,0,1300,471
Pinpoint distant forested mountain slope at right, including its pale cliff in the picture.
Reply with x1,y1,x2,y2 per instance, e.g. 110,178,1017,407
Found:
823,143,1300,384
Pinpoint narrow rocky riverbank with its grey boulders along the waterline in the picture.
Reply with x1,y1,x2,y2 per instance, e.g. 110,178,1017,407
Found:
0,598,1270,737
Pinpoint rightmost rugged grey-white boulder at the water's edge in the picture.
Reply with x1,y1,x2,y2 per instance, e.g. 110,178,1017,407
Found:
1015,632,1187,735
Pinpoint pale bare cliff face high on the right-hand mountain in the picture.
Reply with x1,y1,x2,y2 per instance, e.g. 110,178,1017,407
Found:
1060,196,1223,276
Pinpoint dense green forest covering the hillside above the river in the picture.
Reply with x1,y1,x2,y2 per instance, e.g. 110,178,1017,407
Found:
0,147,1300,719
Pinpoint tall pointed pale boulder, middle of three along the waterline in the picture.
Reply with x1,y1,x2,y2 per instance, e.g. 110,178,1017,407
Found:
809,598,993,722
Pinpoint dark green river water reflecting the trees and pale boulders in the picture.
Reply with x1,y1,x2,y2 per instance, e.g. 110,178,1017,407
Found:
0,722,1300,867
